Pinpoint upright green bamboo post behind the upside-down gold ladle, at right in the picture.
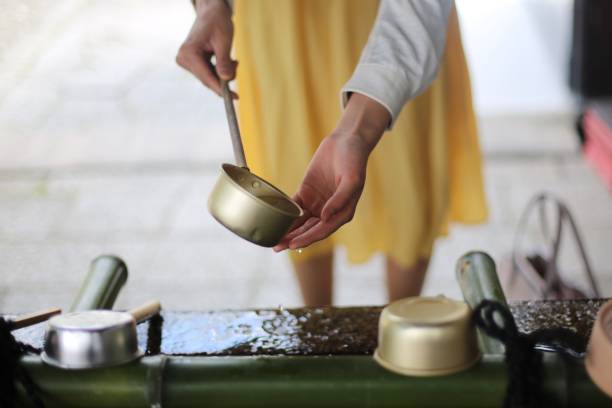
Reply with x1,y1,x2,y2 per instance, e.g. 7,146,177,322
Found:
455,251,508,354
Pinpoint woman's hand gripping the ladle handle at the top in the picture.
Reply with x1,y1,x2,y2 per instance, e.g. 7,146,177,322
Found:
176,0,237,95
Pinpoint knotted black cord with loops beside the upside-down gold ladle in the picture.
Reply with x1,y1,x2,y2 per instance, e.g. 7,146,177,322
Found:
474,300,586,408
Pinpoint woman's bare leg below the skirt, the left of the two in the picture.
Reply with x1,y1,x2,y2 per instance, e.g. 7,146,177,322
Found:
293,252,334,307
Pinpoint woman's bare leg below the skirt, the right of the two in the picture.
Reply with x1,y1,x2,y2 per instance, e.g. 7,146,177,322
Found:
387,257,429,302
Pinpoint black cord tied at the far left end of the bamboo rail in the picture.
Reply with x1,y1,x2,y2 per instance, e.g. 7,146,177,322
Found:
0,317,45,408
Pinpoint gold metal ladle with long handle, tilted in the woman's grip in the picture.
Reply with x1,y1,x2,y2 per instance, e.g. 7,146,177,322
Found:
208,81,304,247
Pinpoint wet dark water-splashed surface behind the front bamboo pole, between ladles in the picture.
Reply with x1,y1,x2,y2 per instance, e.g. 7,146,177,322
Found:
4,299,605,356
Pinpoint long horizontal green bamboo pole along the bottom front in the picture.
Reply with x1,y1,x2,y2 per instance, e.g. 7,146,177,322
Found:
19,353,612,408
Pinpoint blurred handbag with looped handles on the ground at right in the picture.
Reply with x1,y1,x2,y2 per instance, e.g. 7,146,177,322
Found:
500,193,600,300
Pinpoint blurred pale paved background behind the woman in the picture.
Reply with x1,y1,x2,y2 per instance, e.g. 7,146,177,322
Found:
0,0,612,312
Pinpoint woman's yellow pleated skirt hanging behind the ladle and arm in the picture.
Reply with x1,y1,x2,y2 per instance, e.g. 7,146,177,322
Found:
234,0,487,266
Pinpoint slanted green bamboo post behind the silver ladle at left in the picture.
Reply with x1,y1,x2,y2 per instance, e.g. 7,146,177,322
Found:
70,255,128,312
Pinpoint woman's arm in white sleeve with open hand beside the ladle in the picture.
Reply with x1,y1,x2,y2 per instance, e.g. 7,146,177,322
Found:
274,0,452,251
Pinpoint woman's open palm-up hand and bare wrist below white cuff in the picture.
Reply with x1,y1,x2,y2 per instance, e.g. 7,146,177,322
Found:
274,94,390,252
